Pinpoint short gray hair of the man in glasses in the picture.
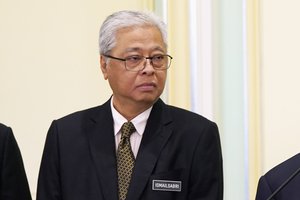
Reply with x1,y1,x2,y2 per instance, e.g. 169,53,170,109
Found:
99,10,167,54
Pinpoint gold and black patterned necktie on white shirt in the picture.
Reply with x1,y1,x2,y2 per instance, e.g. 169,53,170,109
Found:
117,122,135,200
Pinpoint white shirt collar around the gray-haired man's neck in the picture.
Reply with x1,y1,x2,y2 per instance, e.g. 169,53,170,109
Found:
110,97,153,135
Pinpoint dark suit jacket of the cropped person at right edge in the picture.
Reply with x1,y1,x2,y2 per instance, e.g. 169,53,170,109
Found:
256,154,300,200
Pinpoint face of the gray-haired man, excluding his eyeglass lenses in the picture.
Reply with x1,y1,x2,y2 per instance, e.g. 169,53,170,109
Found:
101,26,167,107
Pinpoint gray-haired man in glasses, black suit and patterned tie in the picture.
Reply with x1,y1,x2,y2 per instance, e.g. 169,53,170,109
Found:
37,11,223,200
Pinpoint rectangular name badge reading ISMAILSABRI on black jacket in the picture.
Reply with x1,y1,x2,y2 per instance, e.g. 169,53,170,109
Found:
152,180,181,192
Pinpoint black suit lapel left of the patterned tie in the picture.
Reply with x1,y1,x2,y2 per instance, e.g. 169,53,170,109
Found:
88,101,118,200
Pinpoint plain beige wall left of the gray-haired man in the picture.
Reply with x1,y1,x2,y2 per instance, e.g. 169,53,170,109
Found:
0,0,149,197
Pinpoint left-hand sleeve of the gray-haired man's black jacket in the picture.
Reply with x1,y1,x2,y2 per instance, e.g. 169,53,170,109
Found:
36,121,62,200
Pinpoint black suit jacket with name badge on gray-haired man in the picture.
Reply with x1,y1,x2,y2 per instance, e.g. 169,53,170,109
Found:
37,100,223,200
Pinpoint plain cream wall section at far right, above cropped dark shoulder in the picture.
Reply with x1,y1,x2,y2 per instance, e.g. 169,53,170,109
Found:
261,0,300,173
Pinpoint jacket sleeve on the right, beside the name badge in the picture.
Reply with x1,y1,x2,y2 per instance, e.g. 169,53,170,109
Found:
188,123,223,200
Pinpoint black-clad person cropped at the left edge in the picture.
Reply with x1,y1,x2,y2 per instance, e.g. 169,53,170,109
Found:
0,124,31,200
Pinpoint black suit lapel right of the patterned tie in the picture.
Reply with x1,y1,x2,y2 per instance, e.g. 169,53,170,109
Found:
127,100,172,200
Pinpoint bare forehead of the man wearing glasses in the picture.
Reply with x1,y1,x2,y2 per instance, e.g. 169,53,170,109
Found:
115,25,166,51
